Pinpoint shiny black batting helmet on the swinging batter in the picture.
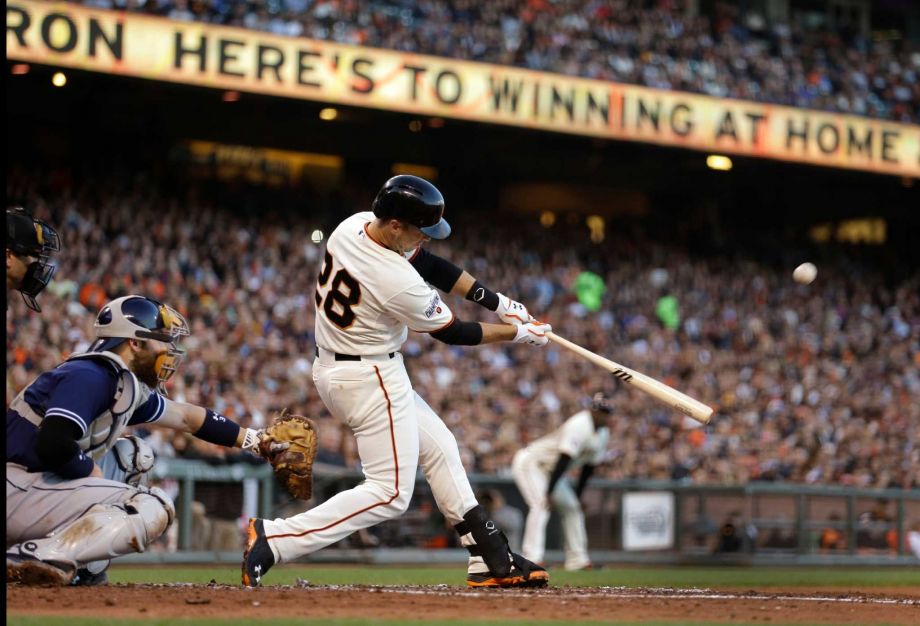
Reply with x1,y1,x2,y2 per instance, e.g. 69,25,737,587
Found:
373,174,450,239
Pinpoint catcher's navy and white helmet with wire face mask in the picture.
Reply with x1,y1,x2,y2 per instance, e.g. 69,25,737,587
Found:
89,296,189,394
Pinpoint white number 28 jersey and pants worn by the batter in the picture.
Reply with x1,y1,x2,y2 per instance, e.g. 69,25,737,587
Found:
264,212,477,563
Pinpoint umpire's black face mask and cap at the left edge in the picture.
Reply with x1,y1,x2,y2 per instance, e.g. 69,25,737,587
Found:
6,207,61,311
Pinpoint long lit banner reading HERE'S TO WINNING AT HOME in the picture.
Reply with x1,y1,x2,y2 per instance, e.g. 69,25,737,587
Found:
6,0,920,176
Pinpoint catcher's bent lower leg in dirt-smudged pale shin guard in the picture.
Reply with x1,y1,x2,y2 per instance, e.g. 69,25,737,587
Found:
6,487,175,572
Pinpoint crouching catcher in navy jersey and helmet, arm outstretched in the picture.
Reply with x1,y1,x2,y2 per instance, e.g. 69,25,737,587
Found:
6,296,274,585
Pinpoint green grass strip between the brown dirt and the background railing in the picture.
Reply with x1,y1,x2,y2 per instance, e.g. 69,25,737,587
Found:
109,565,920,589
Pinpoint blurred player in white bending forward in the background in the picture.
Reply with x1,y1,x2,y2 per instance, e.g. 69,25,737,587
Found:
511,393,612,570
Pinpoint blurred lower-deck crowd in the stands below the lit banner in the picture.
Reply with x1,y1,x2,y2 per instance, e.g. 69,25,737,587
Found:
6,168,920,489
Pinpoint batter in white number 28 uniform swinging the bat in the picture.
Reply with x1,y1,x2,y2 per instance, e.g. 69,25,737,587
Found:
242,176,551,587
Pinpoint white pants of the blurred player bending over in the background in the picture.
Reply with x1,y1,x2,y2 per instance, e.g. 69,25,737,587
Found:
511,449,591,570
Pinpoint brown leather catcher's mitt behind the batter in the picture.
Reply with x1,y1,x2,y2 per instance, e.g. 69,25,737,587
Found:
259,409,318,500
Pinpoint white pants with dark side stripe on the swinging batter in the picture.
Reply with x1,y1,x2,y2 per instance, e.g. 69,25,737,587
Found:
265,351,476,563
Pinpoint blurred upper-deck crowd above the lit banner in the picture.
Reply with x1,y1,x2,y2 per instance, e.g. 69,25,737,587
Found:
73,0,920,123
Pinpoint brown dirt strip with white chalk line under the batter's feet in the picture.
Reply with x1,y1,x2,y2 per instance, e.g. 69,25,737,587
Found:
6,583,920,625
